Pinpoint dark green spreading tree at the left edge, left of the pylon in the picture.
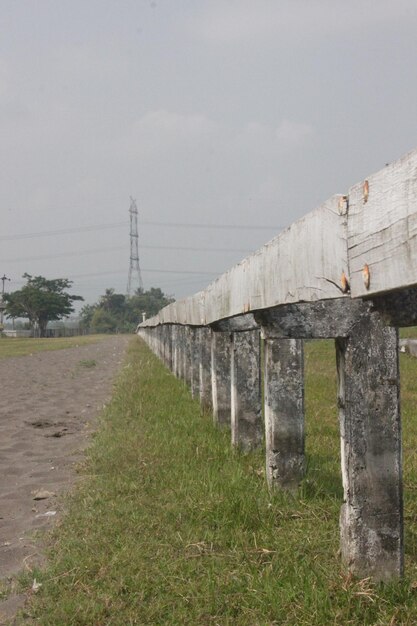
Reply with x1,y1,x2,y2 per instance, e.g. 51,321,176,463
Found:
4,274,84,337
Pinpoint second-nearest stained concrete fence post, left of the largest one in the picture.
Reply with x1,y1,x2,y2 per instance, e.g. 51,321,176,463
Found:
264,338,304,491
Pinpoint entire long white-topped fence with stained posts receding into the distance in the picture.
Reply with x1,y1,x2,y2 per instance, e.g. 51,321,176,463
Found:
138,150,417,580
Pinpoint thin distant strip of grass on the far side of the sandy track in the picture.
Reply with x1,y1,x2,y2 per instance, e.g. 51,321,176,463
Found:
0,335,110,359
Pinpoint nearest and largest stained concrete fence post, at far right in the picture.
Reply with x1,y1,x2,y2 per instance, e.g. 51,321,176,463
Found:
336,313,403,580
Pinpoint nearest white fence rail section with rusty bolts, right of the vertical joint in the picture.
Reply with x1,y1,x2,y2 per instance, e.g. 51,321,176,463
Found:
348,150,417,297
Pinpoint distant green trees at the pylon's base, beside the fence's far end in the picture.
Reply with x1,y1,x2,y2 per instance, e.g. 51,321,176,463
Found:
80,287,174,333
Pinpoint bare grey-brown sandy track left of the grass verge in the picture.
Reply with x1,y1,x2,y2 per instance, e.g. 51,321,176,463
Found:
0,336,131,624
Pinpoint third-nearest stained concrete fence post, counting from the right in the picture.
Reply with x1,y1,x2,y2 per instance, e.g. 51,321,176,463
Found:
231,330,263,451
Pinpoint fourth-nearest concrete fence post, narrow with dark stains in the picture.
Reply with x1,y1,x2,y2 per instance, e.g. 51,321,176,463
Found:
211,332,231,426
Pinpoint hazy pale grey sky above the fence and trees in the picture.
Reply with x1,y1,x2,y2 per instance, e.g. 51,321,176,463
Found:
0,0,417,302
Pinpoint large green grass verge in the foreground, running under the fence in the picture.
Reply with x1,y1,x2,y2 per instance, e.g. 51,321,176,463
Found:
18,340,417,626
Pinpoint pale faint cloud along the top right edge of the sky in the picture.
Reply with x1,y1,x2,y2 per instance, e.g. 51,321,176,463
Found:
188,0,417,44
